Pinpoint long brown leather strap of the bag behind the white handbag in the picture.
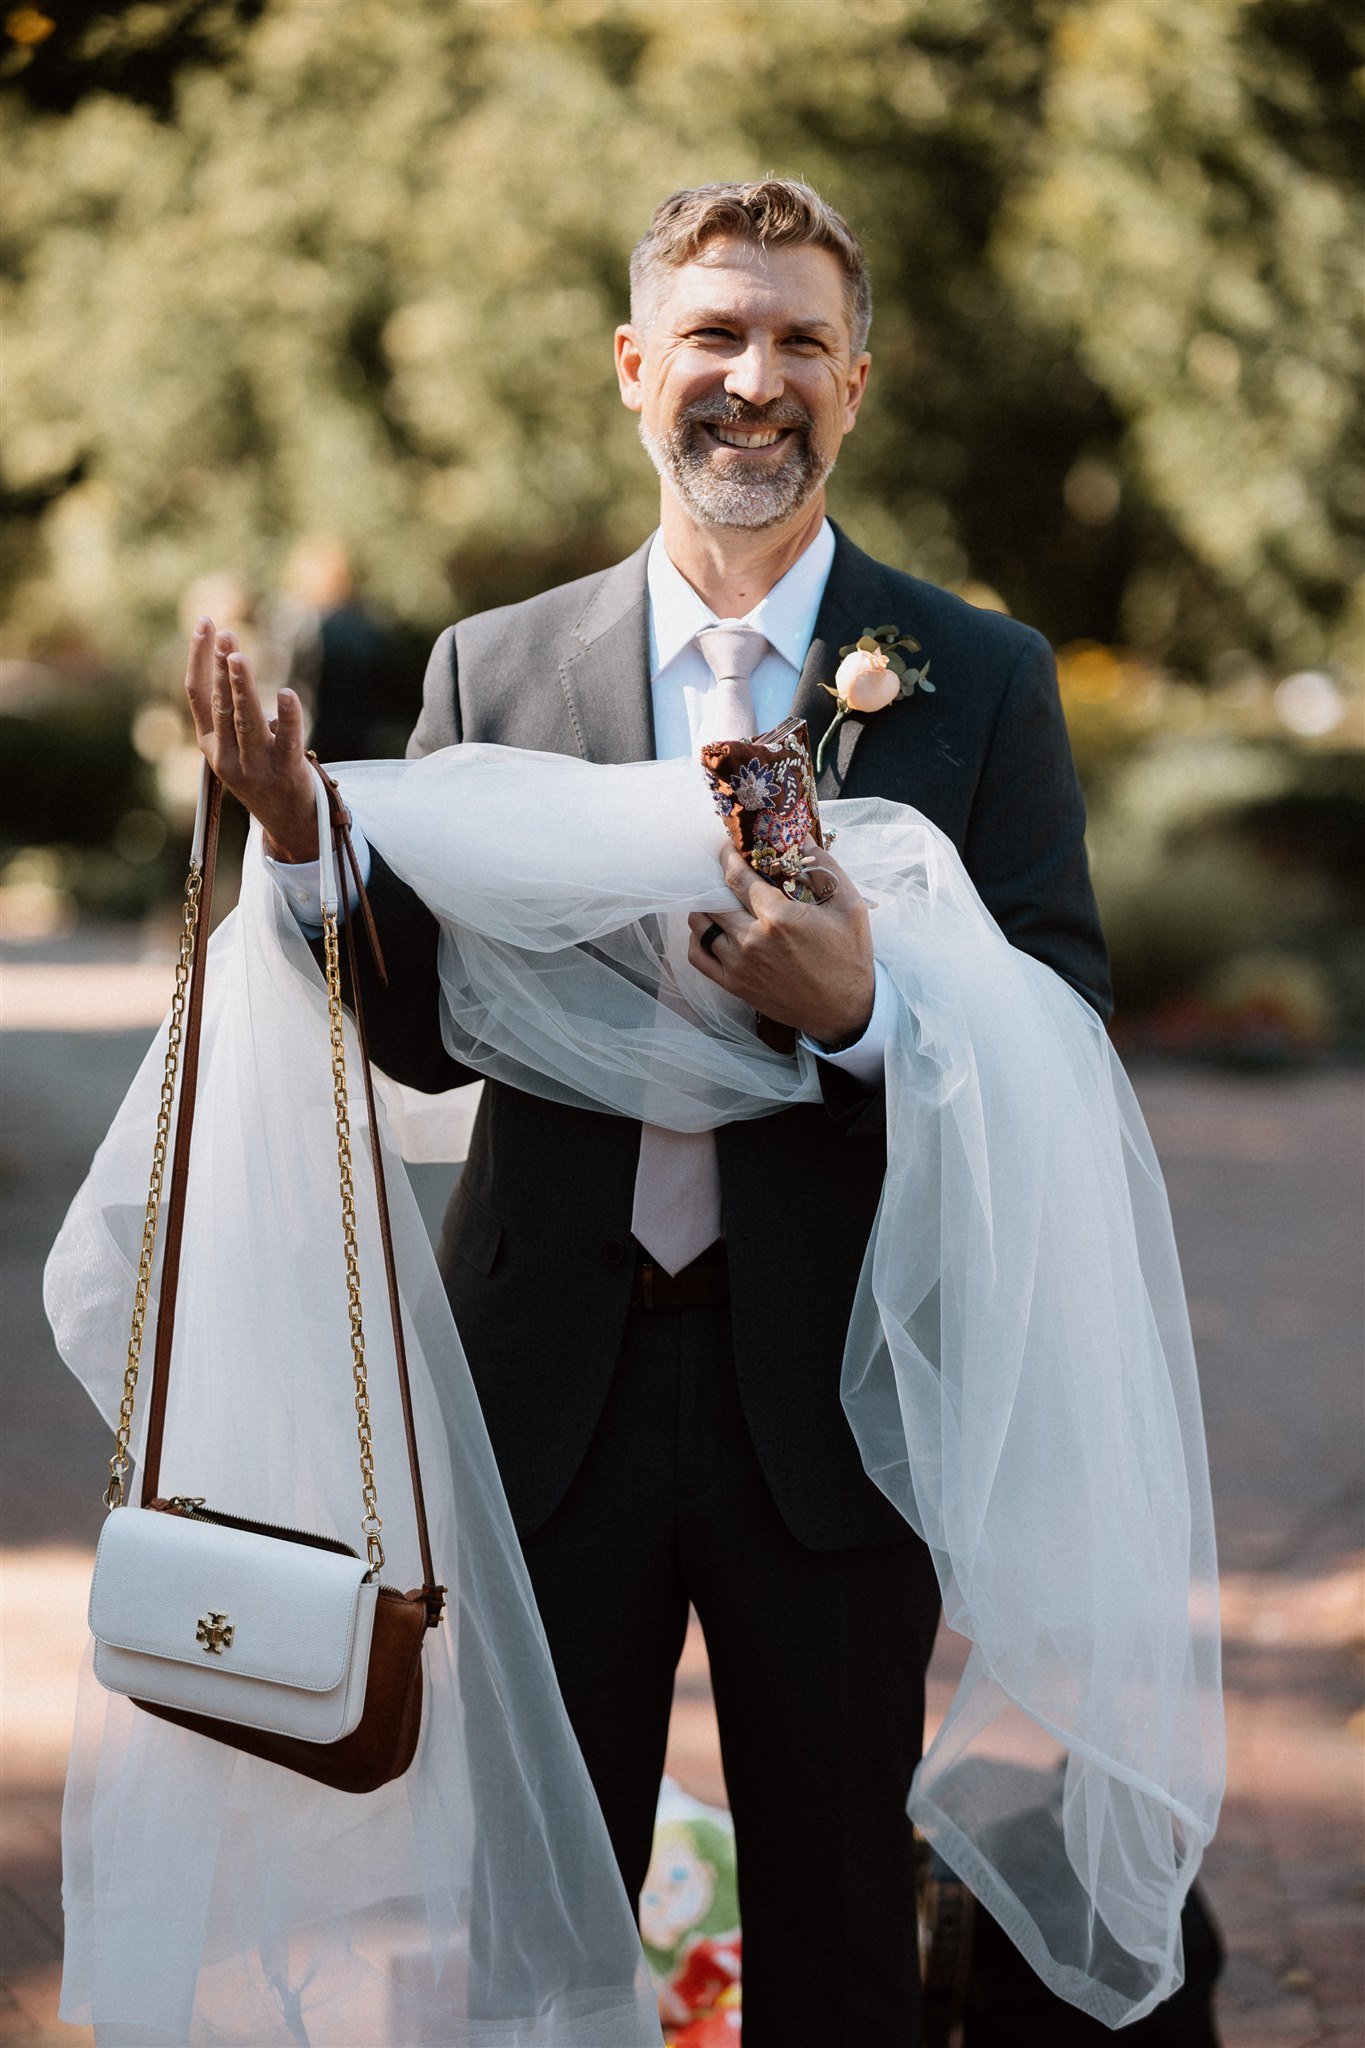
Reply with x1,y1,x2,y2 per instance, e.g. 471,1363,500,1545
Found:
141,760,446,1628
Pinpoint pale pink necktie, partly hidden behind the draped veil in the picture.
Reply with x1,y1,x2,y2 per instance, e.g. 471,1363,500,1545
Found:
630,623,767,1274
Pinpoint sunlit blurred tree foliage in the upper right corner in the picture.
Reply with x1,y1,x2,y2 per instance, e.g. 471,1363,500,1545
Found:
997,0,1365,664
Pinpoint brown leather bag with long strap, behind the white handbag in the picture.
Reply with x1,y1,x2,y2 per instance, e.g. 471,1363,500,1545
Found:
106,760,446,1792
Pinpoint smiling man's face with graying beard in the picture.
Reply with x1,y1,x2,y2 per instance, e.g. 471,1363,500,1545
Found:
616,236,870,528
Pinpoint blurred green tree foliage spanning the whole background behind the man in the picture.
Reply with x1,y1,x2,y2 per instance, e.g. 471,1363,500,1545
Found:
0,0,1365,670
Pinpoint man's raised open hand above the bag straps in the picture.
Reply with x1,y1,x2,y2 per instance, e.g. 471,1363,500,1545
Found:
184,618,317,860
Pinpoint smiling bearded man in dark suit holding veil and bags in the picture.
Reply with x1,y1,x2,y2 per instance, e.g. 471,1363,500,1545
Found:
188,178,1107,2048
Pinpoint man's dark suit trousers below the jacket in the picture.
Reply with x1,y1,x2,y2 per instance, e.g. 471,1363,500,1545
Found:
524,1309,939,2048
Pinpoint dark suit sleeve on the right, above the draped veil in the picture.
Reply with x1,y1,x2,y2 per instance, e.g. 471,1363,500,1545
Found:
964,633,1113,1020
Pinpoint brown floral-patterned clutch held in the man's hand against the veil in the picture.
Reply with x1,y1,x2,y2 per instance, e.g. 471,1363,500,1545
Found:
702,719,827,1053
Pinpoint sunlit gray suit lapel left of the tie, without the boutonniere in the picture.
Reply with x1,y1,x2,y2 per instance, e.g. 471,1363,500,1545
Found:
559,541,655,762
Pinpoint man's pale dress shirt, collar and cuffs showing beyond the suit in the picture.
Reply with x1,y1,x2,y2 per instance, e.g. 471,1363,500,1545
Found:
266,520,892,1087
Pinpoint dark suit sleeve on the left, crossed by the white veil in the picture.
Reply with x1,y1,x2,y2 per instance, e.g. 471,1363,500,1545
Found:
331,627,481,1096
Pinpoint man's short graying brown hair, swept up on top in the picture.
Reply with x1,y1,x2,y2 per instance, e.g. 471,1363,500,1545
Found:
630,178,872,356
